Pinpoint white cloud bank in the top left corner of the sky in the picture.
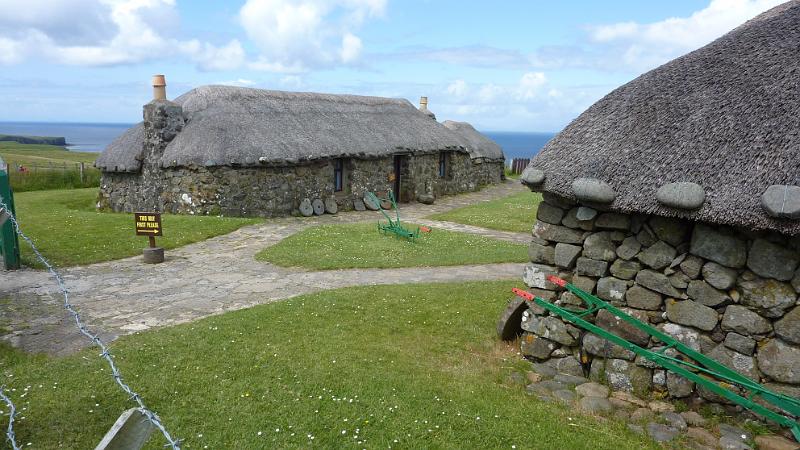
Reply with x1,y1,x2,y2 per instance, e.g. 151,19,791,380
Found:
0,0,244,70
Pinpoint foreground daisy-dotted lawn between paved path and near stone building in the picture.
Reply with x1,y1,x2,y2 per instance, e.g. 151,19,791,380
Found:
0,282,658,450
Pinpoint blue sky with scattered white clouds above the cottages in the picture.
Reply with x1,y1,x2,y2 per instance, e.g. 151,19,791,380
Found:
0,0,781,132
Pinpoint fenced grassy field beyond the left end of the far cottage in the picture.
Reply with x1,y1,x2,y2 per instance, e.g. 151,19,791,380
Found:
0,142,100,192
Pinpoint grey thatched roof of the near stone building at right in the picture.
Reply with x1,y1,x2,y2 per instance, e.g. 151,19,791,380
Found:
529,0,800,234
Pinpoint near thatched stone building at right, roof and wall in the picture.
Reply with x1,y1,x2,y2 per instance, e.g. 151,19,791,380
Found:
523,0,800,400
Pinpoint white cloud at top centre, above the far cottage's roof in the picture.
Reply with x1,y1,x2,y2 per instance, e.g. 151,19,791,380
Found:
239,0,387,73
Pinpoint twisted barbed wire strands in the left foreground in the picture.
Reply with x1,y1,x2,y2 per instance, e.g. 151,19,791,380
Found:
0,197,181,450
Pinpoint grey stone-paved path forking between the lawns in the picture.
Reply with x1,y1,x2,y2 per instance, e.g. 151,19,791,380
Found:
0,182,530,354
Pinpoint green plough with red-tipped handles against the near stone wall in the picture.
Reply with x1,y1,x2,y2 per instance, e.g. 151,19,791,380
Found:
513,275,800,442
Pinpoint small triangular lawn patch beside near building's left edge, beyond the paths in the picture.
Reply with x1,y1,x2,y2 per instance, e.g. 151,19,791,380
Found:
430,192,542,233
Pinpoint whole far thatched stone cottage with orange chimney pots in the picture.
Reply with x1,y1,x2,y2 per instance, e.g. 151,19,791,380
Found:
96,81,504,216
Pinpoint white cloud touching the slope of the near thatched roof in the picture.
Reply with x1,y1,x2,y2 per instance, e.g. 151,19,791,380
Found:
589,0,784,70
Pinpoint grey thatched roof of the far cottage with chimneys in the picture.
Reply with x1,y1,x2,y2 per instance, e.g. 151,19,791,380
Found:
96,86,484,171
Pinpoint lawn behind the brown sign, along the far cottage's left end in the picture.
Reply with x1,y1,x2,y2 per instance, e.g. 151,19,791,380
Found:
14,188,259,267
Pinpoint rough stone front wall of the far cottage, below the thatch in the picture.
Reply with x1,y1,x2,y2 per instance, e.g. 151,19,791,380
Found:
97,153,503,217
